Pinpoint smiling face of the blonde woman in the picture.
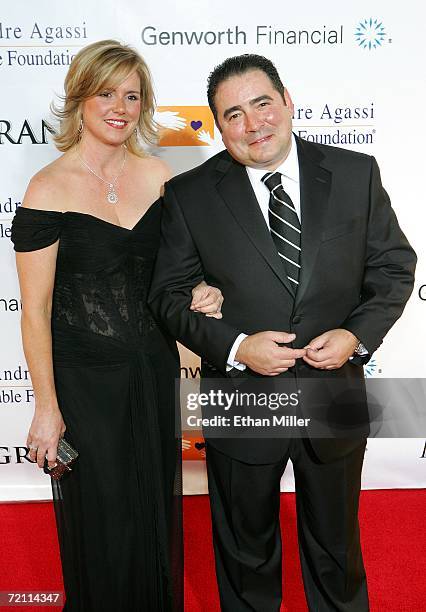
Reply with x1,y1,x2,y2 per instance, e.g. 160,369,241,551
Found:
82,72,141,146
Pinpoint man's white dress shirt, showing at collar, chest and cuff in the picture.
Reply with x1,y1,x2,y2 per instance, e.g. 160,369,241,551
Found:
228,134,302,371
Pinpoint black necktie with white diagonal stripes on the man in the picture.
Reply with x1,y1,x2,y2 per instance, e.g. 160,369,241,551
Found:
262,172,301,295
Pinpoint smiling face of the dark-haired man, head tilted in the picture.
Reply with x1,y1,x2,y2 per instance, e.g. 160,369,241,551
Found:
215,69,293,170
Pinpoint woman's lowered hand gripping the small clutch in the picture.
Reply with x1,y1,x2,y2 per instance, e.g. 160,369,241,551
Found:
27,405,66,468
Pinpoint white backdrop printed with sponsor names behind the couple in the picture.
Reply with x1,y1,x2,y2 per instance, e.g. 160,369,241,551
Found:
0,0,426,501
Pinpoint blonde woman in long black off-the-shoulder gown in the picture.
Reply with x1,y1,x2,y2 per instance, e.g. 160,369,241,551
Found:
12,41,221,612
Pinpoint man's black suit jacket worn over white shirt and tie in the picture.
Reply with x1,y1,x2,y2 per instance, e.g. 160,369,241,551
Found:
150,138,416,463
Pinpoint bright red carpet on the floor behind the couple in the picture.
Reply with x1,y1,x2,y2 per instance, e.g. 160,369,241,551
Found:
0,490,426,612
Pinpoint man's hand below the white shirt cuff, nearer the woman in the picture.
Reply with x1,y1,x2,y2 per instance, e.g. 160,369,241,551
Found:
235,331,306,376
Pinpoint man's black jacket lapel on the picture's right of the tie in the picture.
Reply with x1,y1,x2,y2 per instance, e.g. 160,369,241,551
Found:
295,138,331,308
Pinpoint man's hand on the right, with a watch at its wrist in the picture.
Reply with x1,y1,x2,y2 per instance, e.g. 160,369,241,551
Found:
303,329,358,370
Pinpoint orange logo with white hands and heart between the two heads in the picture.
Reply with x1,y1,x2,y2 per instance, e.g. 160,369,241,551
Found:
154,106,214,147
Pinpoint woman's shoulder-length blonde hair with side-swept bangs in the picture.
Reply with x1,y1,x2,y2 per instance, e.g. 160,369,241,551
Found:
51,40,157,157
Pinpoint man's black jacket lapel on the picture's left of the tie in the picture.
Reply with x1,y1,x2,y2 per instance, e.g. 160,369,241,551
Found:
216,154,293,295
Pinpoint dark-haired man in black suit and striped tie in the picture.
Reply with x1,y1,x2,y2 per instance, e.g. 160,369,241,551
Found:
150,55,416,612
